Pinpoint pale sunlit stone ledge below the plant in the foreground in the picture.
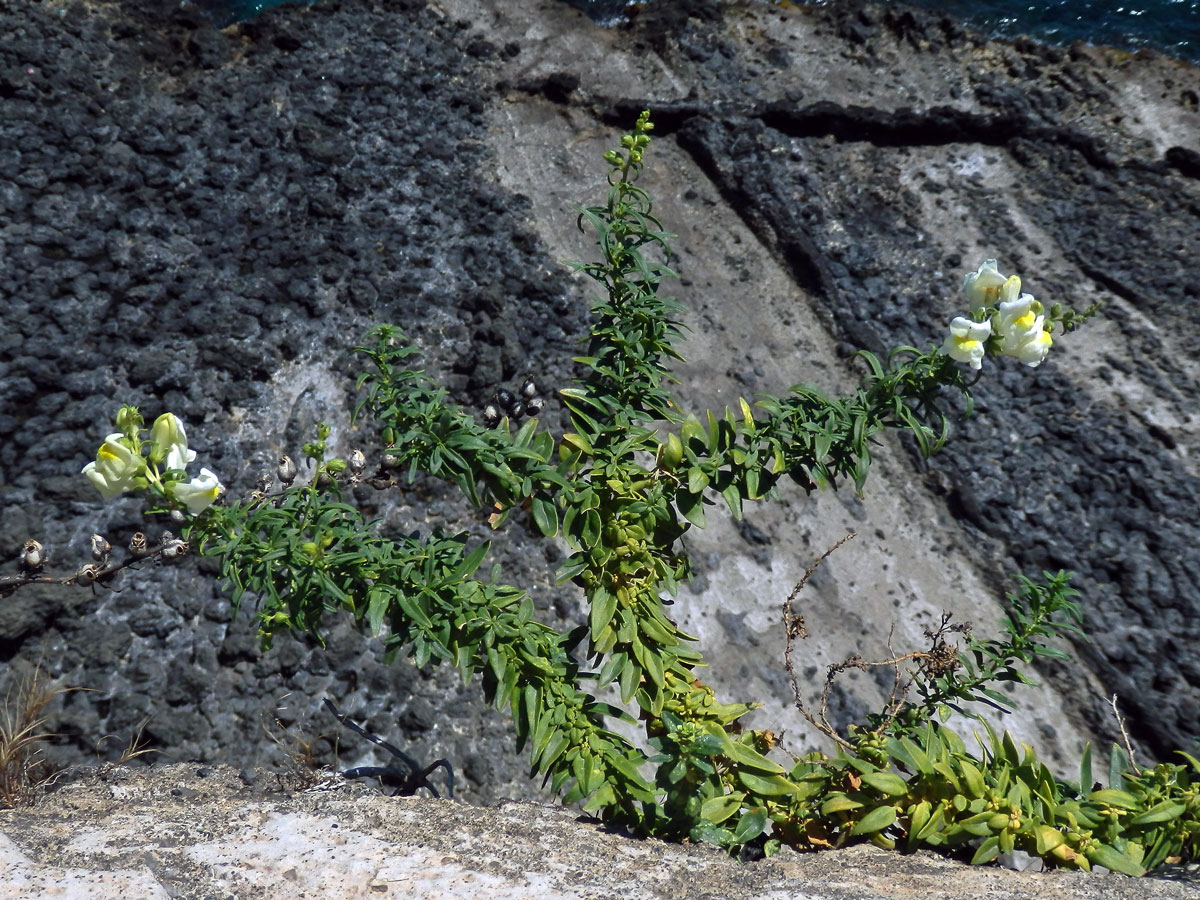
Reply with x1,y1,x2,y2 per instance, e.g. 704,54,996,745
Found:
0,764,1196,900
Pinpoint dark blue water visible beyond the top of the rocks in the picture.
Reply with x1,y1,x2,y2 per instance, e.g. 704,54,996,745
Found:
194,0,1200,65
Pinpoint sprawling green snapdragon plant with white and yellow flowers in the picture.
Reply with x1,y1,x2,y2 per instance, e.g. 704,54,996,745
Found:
49,113,1200,874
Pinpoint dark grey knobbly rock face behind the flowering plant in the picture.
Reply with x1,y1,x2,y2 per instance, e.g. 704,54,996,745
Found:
0,0,1200,816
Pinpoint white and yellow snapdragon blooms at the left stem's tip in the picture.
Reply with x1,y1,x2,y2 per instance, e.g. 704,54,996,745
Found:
83,407,224,516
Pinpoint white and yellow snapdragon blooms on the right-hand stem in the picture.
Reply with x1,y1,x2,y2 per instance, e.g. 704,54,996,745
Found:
942,259,1054,368
